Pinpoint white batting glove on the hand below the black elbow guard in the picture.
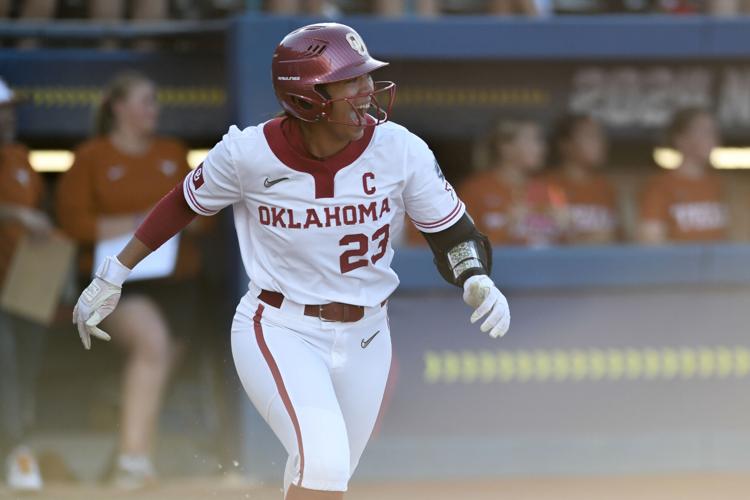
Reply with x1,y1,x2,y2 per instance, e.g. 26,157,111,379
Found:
464,274,510,338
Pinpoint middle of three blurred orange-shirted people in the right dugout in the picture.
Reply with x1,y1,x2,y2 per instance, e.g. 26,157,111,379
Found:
548,115,618,244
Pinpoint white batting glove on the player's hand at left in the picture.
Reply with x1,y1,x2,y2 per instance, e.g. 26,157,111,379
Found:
73,257,130,349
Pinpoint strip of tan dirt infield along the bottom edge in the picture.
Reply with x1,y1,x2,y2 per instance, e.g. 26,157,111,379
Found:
0,475,750,500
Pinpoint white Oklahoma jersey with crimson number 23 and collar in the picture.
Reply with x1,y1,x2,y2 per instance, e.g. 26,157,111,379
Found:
183,118,465,306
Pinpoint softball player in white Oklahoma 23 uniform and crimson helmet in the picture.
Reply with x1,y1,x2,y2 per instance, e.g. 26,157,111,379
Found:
73,23,510,500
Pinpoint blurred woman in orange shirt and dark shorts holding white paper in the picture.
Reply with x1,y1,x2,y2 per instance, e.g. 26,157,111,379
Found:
56,72,199,489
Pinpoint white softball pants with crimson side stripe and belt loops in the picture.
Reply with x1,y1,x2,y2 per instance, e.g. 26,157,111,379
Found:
232,294,391,495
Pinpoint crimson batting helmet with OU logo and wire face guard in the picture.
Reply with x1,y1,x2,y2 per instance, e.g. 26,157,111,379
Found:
271,23,396,126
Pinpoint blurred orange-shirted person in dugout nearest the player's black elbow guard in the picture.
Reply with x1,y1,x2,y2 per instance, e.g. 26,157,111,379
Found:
459,121,566,246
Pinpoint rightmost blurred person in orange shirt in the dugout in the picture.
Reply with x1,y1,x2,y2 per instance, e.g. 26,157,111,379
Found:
638,108,729,244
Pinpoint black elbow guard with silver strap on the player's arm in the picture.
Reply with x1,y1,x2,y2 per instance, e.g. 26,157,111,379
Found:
422,214,492,287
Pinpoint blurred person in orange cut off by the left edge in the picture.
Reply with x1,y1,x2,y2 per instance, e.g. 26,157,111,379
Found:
0,79,52,491
